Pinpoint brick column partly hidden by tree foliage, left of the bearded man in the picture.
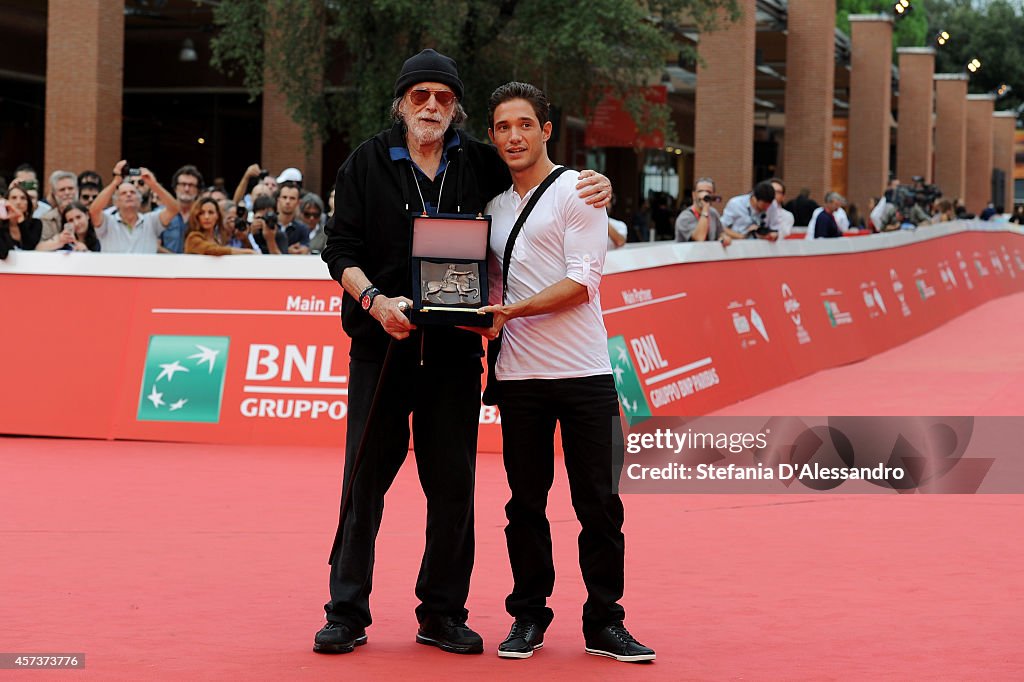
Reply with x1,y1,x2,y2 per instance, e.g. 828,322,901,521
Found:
260,3,319,193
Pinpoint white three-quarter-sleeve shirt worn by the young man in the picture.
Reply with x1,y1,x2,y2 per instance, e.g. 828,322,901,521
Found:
486,163,611,381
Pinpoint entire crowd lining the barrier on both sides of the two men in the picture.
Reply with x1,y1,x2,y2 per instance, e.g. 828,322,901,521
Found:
0,161,1024,257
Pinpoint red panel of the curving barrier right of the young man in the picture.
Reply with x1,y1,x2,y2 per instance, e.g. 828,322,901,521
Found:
601,232,1024,417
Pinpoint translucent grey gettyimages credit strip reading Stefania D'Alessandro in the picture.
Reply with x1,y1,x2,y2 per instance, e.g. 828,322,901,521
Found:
612,417,1024,494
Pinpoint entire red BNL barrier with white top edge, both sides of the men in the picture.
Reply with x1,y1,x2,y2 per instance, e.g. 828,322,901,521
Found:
0,226,1024,452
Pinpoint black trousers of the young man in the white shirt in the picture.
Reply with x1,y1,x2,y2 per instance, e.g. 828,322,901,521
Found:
499,375,626,633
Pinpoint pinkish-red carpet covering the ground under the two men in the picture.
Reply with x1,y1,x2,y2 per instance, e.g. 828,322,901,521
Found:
0,296,1024,680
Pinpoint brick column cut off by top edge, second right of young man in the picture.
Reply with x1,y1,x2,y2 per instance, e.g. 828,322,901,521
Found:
782,0,836,201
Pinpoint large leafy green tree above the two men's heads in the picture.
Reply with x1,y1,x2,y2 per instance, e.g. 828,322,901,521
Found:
212,0,738,147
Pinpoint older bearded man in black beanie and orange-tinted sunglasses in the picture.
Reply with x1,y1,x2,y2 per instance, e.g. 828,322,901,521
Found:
313,49,611,653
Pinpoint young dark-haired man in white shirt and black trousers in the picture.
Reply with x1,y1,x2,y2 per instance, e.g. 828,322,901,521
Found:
484,83,654,662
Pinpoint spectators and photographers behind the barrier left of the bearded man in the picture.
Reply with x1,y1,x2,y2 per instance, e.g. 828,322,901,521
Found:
0,161,334,258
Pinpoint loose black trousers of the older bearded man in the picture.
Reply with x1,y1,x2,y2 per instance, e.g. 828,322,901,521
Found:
325,344,481,628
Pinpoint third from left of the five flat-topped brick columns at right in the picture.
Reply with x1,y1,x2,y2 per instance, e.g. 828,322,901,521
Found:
934,74,967,201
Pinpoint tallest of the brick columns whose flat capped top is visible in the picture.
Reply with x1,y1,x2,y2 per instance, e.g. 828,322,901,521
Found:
847,14,893,206
